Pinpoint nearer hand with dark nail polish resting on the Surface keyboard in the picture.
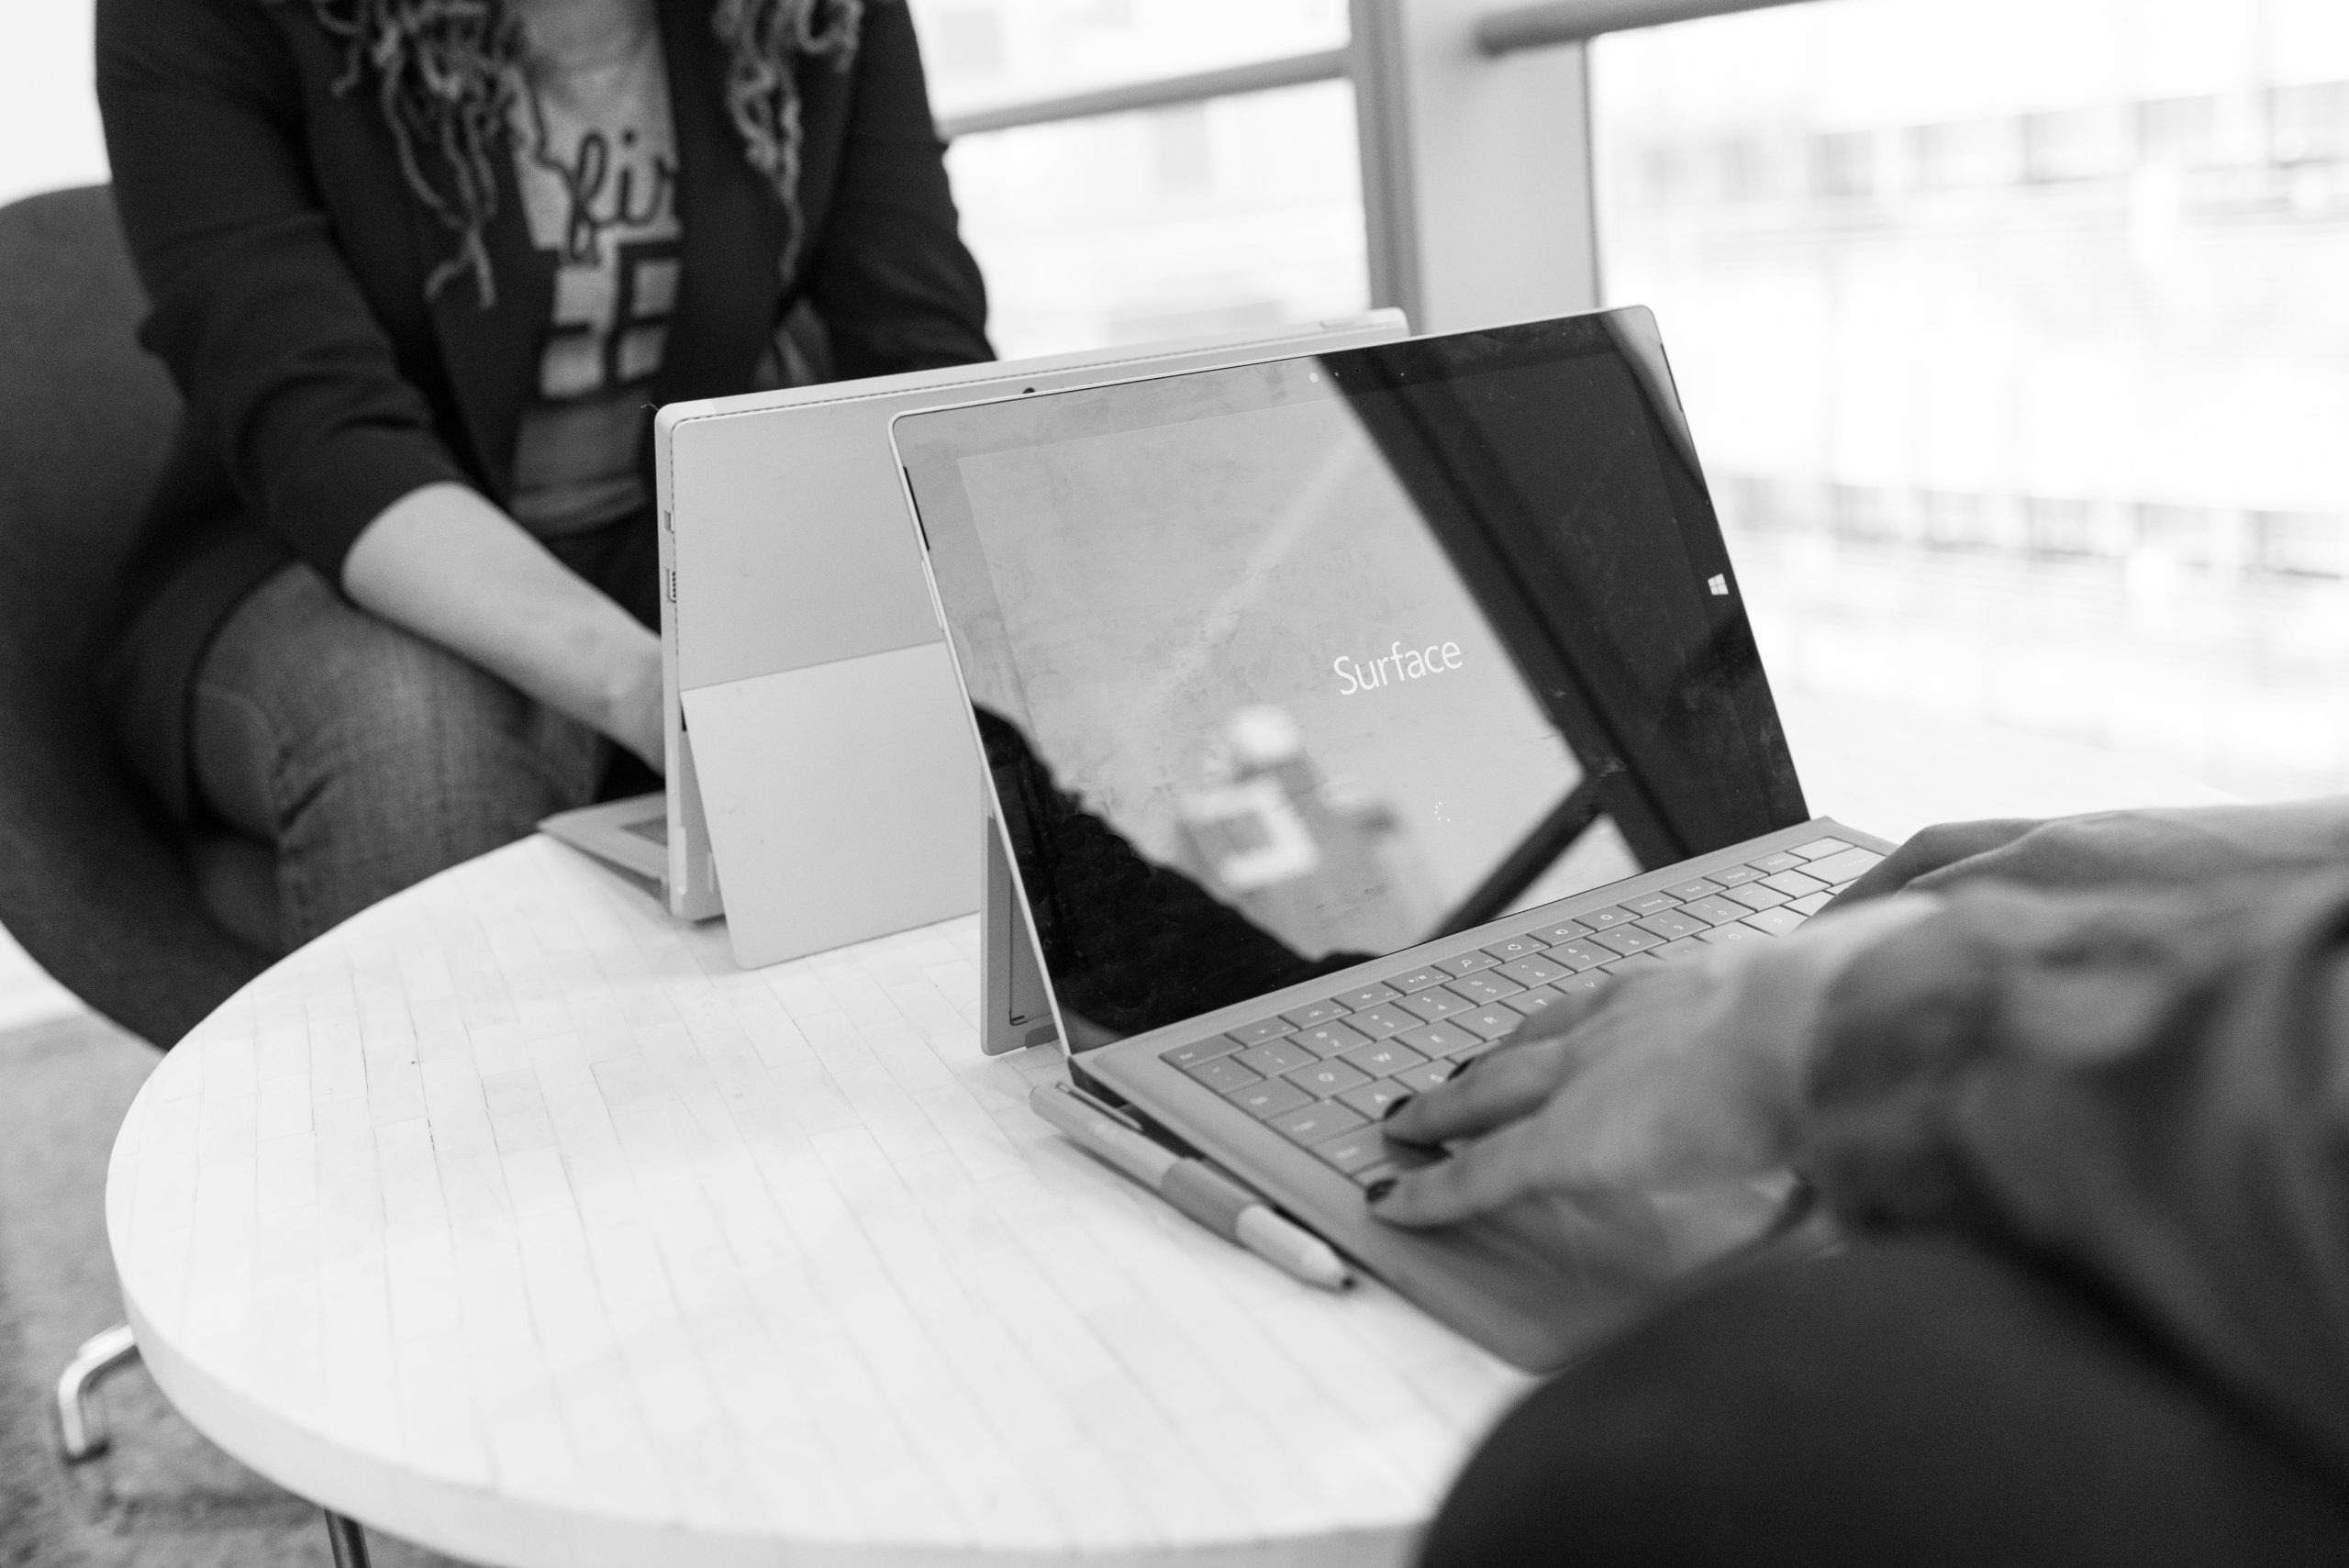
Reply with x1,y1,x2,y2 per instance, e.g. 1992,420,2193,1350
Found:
1372,899,1938,1258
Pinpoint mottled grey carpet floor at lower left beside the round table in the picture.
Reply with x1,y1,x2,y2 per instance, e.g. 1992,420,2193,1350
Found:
0,1017,467,1568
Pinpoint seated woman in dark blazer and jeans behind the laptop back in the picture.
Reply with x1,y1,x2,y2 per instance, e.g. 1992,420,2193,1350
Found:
99,0,989,951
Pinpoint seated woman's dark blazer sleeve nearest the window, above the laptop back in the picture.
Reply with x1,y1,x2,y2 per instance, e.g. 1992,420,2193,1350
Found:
808,0,994,380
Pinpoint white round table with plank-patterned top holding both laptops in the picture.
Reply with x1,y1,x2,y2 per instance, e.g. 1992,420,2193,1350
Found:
106,838,1522,1568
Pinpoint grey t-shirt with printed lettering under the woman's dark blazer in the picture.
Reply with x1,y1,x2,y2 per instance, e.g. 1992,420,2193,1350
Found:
512,30,684,538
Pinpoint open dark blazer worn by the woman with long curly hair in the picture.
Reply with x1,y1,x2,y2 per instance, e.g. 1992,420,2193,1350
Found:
96,0,991,819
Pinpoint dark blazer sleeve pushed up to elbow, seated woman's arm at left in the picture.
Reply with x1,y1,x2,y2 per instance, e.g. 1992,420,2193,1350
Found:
96,0,470,582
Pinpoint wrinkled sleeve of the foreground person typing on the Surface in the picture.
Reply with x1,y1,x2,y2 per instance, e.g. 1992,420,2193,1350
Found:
1809,866,2349,1479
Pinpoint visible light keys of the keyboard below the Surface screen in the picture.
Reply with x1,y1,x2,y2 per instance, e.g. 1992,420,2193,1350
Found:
1158,838,1884,1185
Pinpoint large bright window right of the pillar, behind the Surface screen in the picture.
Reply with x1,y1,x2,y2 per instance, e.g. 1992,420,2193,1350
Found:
1593,0,2349,795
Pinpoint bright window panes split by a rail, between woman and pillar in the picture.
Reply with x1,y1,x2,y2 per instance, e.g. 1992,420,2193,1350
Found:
914,0,1369,357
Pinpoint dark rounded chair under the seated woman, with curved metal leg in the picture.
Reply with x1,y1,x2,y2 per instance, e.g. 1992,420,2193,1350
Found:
0,185,268,1460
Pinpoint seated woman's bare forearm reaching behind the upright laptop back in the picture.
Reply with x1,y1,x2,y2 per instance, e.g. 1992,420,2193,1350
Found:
343,484,662,768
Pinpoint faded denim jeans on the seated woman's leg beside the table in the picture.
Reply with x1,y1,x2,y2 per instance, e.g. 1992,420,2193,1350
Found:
188,563,613,951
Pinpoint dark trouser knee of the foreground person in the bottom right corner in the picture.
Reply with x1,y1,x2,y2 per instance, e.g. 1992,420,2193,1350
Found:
1421,1237,2349,1568
